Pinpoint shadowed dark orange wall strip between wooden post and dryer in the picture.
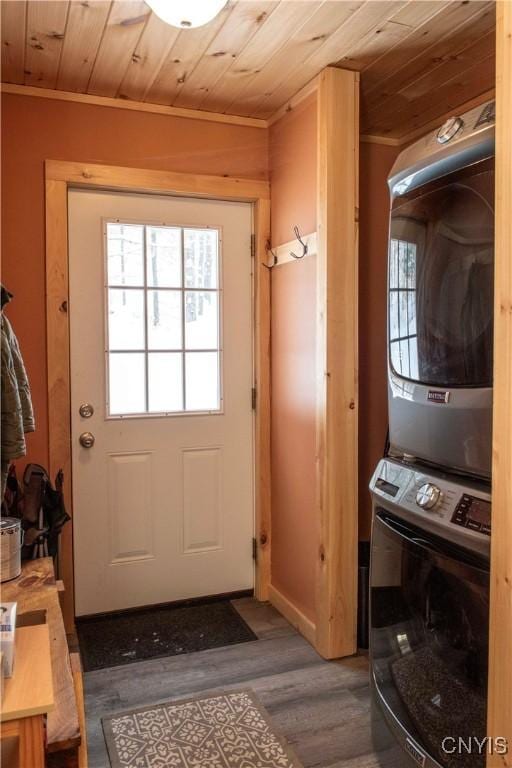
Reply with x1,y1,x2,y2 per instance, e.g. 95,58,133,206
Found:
359,143,399,540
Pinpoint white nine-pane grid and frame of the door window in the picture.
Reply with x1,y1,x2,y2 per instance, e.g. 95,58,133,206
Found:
103,219,223,419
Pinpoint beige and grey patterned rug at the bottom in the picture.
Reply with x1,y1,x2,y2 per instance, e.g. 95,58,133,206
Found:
103,690,302,768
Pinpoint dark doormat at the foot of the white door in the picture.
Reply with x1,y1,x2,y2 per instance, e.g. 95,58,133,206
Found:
76,599,257,672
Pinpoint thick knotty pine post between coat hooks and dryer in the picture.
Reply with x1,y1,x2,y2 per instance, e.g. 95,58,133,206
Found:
316,67,359,658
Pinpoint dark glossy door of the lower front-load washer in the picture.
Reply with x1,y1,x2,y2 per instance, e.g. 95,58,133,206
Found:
370,510,489,768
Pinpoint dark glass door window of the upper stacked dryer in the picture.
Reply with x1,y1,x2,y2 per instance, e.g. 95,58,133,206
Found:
388,160,494,387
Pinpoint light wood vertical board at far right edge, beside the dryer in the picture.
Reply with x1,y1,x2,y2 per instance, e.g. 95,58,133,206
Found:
487,0,512,768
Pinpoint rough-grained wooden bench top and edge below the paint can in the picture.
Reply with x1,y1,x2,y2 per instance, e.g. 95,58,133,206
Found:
2,557,83,754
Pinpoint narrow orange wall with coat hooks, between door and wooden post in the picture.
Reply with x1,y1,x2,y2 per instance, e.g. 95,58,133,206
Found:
269,96,318,620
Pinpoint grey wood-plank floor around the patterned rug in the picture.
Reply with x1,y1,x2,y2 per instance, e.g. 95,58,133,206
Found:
84,598,395,768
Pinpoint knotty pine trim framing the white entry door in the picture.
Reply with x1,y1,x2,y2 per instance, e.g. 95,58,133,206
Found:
45,160,271,629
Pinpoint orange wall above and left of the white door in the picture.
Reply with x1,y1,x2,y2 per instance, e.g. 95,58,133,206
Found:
2,94,268,472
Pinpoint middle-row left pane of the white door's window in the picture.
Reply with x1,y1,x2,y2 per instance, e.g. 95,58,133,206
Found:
108,288,144,350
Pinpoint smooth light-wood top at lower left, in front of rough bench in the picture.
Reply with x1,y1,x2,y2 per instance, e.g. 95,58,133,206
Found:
0,624,55,723
